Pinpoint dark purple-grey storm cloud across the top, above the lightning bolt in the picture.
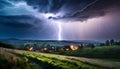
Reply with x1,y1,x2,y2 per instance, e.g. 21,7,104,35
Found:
26,0,120,21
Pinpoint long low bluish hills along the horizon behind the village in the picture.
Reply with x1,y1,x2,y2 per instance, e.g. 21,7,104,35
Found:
0,38,100,47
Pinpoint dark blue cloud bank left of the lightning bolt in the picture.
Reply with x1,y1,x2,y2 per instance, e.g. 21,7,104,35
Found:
0,15,55,39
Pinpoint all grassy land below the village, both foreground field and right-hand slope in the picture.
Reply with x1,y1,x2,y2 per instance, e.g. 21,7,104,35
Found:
0,43,120,69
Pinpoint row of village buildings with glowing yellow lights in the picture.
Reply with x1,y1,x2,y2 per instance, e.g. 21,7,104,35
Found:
25,45,83,52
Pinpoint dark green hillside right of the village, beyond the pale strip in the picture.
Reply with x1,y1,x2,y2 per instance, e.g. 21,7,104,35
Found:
50,46,120,58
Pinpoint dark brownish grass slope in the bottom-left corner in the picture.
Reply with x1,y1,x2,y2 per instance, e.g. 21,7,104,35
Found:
0,48,40,69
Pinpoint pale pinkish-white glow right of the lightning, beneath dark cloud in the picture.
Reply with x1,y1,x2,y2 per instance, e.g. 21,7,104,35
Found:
62,17,105,40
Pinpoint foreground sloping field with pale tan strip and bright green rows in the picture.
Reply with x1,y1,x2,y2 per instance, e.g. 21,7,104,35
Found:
0,48,120,69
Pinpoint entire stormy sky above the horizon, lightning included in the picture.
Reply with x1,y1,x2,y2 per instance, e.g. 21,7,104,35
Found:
0,0,120,40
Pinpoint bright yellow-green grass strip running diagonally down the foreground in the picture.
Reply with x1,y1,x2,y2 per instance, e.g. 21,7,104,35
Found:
24,53,105,69
